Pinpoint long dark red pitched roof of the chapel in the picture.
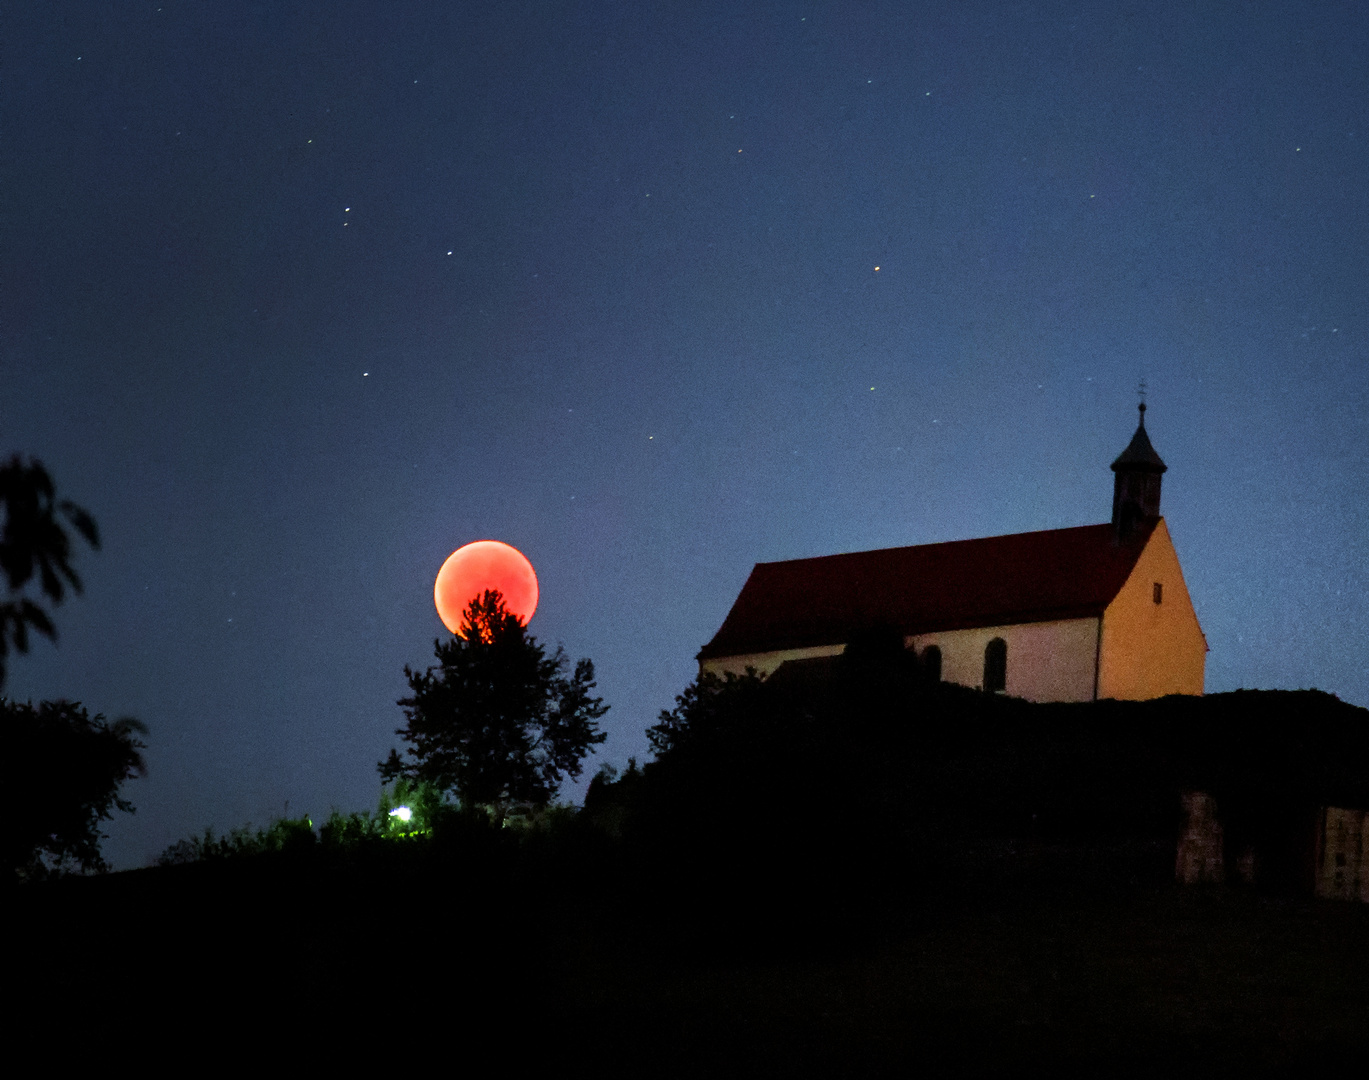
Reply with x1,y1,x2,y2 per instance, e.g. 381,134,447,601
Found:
698,523,1154,660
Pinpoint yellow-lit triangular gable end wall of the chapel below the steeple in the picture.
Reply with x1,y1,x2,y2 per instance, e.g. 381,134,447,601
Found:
1098,519,1207,701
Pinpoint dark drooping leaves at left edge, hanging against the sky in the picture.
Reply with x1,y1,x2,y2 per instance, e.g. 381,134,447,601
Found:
0,454,100,687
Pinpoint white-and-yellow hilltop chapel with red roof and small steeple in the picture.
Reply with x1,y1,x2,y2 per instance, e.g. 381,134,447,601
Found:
698,402,1207,701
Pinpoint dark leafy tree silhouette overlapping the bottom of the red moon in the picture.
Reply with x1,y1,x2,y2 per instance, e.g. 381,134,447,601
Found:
379,590,608,812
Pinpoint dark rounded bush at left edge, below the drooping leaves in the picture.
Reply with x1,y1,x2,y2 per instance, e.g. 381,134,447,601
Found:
0,698,146,880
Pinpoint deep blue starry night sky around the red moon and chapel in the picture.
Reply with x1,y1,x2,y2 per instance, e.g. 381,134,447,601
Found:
0,0,1369,866
